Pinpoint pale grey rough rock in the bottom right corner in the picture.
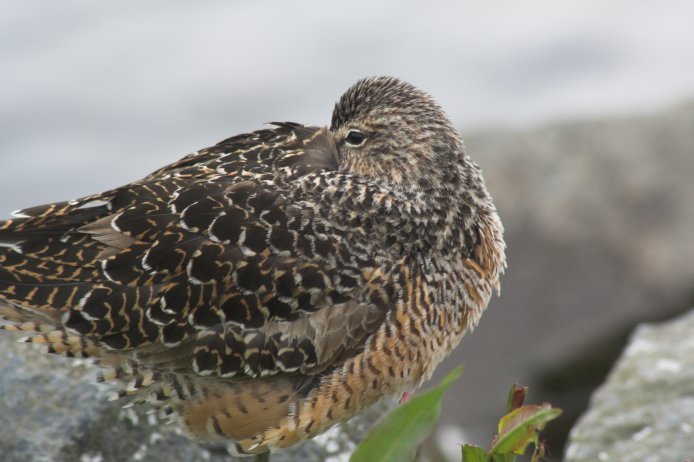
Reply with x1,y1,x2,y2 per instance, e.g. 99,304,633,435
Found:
565,311,694,462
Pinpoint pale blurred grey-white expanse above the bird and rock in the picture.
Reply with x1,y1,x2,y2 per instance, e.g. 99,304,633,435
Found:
0,0,694,216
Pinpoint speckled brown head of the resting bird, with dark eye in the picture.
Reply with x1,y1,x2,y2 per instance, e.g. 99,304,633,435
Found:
330,77,467,191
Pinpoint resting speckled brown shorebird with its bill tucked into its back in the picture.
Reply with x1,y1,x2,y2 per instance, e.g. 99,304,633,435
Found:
0,77,506,454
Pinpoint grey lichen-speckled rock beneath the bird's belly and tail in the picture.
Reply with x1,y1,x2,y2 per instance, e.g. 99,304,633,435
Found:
0,333,386,462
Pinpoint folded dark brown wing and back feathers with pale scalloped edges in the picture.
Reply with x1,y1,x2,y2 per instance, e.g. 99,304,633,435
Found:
0,123,385,379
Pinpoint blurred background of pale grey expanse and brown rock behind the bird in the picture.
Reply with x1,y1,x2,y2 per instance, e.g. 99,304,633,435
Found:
0,0,694,460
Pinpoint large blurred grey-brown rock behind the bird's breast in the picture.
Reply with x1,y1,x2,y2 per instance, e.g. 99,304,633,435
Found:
433,103,694,454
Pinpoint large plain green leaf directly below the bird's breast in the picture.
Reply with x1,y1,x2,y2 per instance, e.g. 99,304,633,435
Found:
349,366,463,462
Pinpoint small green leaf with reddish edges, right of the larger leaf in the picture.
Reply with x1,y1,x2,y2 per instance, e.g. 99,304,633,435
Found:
489,404,561,455
